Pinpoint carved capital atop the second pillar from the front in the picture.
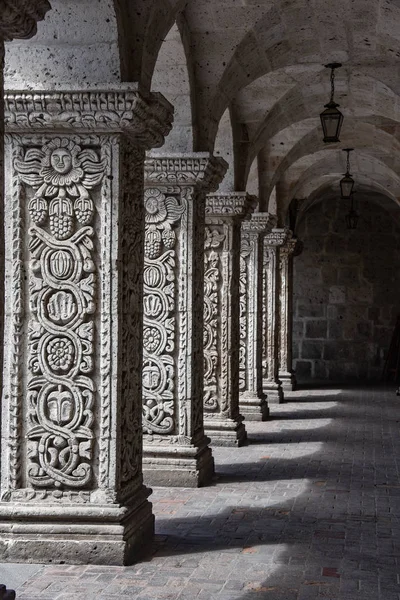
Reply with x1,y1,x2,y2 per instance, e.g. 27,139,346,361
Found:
144,152,228,192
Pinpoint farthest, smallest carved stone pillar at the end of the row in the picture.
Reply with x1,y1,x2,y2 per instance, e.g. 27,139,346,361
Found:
279,239,301,391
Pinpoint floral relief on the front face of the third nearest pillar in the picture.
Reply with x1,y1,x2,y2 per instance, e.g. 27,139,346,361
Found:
203,227,225,412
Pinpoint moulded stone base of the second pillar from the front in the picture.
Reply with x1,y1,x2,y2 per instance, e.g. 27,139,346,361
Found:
143,436,215,487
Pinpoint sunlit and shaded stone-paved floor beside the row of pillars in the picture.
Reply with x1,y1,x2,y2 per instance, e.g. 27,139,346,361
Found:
0,389,400,600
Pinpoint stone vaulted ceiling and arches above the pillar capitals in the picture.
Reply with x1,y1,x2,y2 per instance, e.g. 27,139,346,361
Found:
6,0,400,220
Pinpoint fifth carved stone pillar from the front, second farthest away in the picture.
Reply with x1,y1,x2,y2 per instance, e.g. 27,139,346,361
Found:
263,229,289,404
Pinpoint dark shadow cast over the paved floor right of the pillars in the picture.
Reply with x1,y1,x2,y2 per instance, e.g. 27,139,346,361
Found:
149,391,400,600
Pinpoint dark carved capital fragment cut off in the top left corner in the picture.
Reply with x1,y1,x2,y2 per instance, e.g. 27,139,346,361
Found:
0,0,51,42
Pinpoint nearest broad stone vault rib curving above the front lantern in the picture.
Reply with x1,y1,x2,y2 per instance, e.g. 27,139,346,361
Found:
186,0,400,146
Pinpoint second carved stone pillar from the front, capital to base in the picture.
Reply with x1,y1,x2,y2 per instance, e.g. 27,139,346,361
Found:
143,154,227,487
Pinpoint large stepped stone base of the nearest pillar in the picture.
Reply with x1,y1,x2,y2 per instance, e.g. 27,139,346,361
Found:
0,488,154,566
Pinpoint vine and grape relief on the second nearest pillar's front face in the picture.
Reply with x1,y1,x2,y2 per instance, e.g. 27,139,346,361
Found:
143,188,186,435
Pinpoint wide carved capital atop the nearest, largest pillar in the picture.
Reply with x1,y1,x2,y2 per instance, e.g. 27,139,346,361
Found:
4,88,173,148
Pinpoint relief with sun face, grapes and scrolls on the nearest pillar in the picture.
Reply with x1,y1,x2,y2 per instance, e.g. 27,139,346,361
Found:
14,137,106,490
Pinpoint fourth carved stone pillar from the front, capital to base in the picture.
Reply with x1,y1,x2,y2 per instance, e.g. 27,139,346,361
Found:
239,213,275,421
